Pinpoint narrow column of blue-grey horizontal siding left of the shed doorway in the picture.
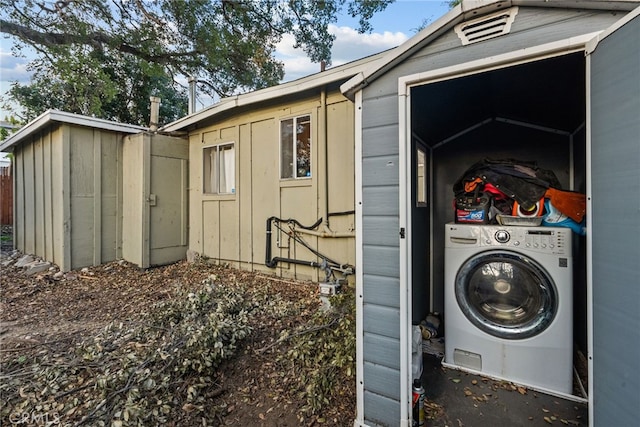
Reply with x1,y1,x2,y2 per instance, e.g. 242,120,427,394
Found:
361,88,400,426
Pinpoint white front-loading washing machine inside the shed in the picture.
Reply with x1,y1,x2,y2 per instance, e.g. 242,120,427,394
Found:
443,224,573,395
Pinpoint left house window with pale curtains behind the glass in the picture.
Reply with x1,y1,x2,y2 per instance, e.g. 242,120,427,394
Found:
203,143,236,194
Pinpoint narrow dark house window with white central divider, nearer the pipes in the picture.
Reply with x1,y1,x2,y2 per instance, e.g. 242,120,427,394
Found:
280,116,311,179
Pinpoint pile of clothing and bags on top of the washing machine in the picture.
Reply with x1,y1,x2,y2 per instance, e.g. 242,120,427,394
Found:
453,159,586,235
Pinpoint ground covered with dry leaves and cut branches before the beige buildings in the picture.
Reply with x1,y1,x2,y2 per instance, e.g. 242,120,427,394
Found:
0,254,355,426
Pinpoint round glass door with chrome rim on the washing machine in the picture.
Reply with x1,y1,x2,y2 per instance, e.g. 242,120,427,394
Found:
455,250,558,340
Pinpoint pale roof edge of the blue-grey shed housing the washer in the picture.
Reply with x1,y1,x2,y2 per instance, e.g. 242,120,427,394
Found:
340,0,640,100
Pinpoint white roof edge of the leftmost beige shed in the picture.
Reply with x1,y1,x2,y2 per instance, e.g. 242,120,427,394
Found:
0,110,147,151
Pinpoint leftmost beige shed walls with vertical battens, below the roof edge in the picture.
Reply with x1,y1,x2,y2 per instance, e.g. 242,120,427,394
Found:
14,124,122,271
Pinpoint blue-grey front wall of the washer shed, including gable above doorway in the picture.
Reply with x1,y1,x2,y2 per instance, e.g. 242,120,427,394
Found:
361,7,623,426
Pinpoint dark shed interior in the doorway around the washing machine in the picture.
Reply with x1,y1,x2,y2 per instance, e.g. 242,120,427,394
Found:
401,48,587,398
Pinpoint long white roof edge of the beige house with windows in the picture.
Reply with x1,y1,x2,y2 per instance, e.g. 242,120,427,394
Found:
161,49,393,132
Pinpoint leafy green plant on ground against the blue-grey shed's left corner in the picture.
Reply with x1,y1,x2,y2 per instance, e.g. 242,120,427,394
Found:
279,289,356,414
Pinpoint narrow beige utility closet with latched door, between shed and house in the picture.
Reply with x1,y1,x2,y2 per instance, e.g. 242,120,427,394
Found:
122,133,188,268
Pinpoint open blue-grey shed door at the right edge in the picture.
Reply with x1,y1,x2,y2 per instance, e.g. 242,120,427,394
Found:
590,17,640,426
